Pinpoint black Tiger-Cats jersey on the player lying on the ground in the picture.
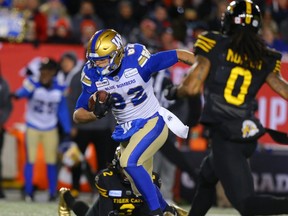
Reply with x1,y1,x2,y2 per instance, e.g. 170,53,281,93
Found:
95,169,160,216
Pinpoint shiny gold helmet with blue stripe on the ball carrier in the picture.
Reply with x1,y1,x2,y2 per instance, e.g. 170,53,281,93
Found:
86,29,124,76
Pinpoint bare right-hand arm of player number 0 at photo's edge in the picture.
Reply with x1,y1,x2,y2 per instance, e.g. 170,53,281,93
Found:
266,72,288,100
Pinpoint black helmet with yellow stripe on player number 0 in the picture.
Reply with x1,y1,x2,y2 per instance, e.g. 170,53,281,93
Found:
221,0,262,35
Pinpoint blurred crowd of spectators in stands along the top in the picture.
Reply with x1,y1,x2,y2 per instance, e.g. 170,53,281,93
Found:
0,0,288,52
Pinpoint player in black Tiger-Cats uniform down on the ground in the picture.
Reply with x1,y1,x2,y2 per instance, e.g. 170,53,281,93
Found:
58,147,188,216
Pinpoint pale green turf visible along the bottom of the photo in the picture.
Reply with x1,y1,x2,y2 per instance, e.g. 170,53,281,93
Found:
0,190,239,216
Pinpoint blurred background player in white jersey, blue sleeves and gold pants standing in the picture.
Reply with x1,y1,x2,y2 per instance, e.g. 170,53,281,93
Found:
13,58,71,201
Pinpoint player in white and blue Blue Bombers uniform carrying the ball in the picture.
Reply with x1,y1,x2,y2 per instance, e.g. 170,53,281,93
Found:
73,29,194,215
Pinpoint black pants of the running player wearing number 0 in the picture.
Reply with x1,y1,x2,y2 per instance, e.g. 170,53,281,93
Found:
189,131,288,216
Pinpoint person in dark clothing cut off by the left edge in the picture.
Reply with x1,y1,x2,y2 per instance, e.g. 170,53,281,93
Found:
0,73,12,199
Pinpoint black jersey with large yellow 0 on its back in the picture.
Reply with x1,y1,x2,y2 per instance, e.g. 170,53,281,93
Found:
195,32,281,123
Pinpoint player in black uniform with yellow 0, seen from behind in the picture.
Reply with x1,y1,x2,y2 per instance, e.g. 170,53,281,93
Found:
166,0,288,216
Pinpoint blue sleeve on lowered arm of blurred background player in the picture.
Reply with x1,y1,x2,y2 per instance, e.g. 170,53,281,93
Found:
58,96,71,134
